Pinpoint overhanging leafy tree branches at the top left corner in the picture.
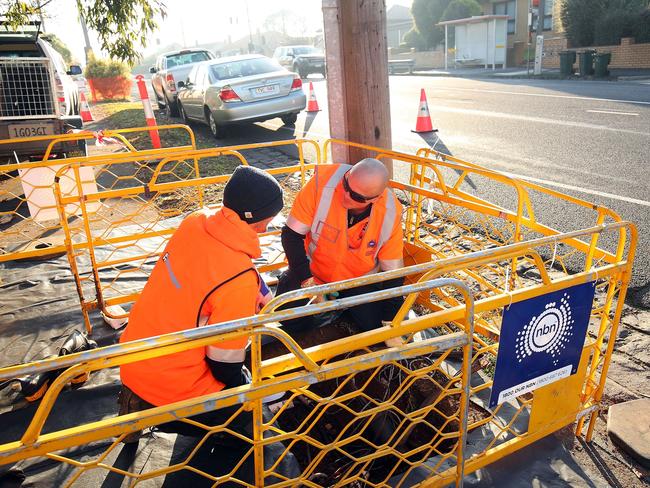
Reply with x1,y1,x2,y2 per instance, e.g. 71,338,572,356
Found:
0,0,166,64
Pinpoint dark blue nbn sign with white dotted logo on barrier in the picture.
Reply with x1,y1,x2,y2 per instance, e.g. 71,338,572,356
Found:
490,282,595,408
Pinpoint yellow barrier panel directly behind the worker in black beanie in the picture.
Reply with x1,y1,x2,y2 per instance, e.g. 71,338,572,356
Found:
54,139,320,330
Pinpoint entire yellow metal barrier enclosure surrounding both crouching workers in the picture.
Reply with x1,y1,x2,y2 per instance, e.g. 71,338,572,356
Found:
0,137,637,486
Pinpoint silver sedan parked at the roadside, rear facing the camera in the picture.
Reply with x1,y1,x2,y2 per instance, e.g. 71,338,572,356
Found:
178,54,306,137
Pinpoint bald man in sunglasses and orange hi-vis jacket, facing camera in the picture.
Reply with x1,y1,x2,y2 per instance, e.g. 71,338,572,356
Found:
277,158,404,346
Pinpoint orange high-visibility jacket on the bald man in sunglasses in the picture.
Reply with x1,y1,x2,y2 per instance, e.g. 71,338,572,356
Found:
287,164,403,283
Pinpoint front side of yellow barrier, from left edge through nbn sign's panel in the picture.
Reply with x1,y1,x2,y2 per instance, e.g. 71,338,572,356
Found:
0,222,636,486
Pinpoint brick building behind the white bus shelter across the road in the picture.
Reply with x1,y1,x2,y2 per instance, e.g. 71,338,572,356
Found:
479,0,564,66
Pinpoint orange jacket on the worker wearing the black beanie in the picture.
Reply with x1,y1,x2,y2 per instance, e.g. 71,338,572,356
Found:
120,208,261,405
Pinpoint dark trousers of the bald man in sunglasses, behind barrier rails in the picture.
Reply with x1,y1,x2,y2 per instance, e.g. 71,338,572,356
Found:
276,269,404,336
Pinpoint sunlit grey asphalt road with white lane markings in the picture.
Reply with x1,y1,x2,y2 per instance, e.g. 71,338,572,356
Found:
251,75,650,308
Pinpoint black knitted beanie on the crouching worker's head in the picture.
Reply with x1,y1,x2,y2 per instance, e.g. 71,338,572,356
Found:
223,166,284,224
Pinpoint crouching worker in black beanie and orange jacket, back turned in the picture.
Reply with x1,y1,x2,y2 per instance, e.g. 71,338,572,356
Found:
120,166,295,480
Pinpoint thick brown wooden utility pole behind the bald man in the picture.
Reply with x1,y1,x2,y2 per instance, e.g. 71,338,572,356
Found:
323,0,392,170
